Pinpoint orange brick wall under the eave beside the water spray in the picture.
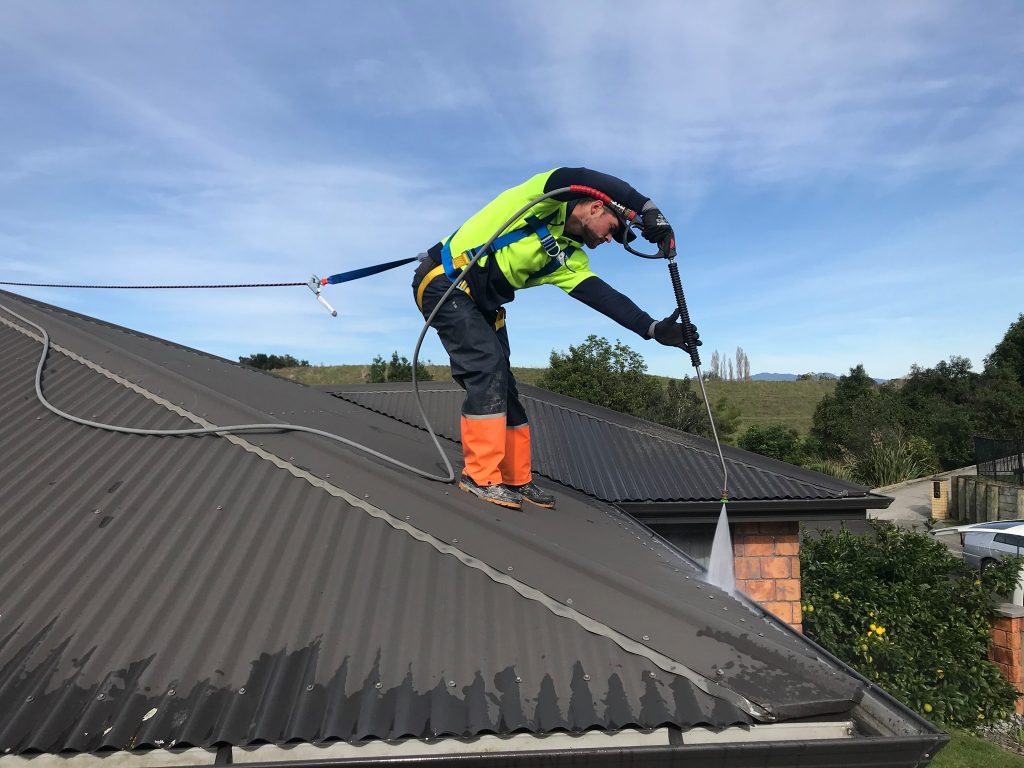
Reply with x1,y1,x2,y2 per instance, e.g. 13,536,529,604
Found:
731,522,803,632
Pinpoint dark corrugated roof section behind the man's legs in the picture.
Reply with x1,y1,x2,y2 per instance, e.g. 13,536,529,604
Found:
324,382,868,503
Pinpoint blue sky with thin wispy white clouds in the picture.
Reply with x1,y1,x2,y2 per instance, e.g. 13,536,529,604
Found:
0,0,1024,378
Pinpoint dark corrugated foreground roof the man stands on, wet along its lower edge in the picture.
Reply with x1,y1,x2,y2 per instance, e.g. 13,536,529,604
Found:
0,292,862,752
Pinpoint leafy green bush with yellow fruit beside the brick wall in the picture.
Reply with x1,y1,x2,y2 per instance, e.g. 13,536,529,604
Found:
800,521,1024,726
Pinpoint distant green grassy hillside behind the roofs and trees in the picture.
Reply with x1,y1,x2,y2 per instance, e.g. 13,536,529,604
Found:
272,366,836,436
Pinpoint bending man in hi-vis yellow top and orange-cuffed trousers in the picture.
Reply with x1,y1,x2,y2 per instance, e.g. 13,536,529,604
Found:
413,168,700,509
